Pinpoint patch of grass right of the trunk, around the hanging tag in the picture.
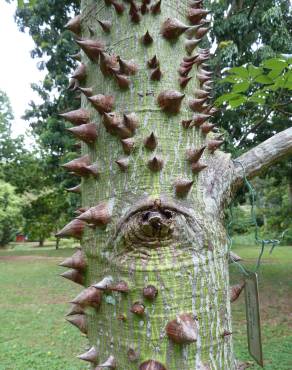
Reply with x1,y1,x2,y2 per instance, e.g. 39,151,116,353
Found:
230,244,292,370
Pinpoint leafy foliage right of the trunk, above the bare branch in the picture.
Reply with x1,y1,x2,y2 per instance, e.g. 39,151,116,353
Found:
209,0,292,152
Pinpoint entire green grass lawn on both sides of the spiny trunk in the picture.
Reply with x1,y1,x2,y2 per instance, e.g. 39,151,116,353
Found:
0,238,292,370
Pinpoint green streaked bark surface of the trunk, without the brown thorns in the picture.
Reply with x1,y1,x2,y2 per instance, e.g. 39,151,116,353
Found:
61,0,236,370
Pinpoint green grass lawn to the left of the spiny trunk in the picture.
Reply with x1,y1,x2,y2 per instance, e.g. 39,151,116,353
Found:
0,243,88,370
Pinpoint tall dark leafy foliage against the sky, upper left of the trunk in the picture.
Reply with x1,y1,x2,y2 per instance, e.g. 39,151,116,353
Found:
16,0,79,158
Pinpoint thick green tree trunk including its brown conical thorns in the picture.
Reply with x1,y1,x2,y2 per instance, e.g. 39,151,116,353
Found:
58,0,292,370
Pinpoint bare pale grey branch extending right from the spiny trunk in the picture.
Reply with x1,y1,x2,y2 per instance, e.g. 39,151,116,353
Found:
232,127,292,190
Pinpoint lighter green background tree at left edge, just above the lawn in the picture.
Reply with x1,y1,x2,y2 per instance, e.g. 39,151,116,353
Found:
0,88,77,245
